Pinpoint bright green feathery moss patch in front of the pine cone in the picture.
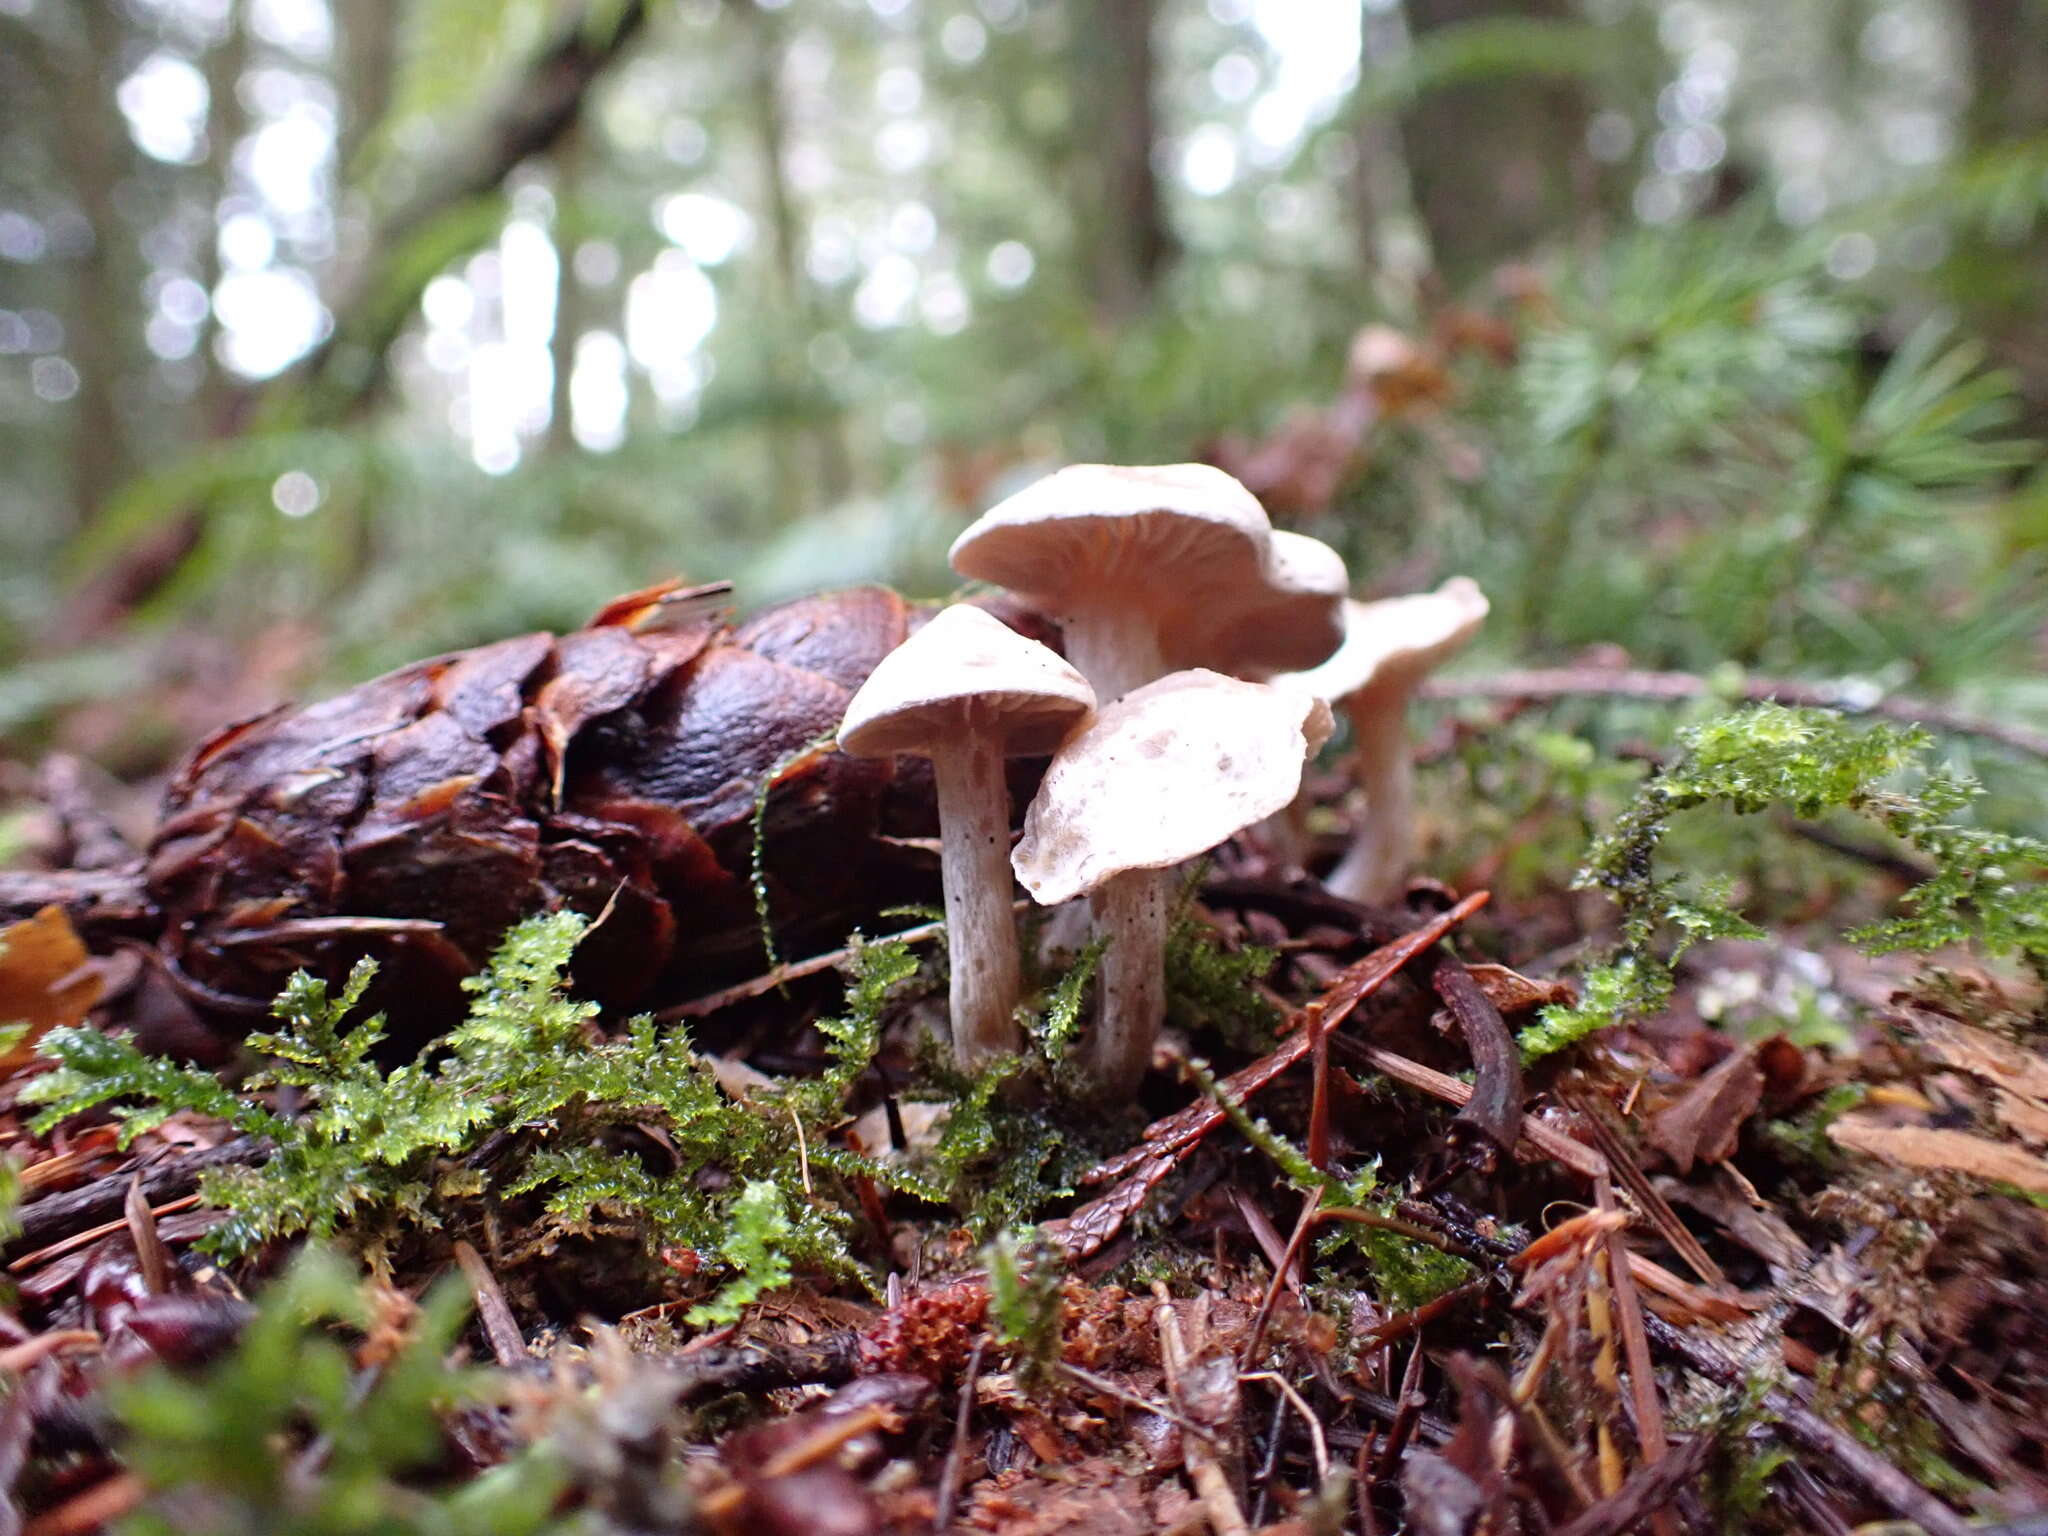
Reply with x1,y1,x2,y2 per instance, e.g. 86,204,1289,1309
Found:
33,913,930,1284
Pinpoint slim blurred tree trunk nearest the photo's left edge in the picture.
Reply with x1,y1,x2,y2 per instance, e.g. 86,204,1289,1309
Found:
49,4,137,528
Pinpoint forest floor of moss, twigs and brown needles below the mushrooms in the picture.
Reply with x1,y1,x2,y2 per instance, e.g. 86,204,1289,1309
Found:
0,593,2048,1536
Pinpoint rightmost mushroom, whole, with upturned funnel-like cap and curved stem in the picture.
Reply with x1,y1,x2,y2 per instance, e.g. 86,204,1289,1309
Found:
1276,575,1487,901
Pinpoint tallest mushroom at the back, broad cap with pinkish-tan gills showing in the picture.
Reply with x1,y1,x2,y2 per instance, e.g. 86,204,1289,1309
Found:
952,465,1343,702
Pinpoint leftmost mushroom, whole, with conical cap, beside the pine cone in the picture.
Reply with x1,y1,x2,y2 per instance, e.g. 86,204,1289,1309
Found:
840,604,1096,1067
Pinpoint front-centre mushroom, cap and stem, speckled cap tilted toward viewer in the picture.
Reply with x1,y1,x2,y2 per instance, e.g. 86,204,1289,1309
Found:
1010,670,1331,1096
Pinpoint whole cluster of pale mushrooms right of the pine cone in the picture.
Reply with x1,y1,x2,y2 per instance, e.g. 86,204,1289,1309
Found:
840,465,1487,1096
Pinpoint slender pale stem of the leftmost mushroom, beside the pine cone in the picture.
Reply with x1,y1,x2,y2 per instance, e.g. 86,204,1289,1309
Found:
932,731,1022,1069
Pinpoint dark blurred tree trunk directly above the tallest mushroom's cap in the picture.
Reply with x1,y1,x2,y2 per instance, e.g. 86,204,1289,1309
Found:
1069,0,1174,322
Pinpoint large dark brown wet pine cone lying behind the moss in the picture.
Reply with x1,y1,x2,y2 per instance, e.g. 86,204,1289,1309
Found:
108,586,1044,1036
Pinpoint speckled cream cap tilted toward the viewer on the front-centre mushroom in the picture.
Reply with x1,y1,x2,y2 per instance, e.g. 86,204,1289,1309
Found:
1010,670,1331,905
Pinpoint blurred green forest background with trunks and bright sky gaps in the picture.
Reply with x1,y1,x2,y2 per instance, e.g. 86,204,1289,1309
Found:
0,0,2048,823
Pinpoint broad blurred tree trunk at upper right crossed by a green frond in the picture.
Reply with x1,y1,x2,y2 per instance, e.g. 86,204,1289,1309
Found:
1401,0,1589,283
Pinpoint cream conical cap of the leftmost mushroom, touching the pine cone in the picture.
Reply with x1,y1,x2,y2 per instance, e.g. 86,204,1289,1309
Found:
840,604,1096,758
